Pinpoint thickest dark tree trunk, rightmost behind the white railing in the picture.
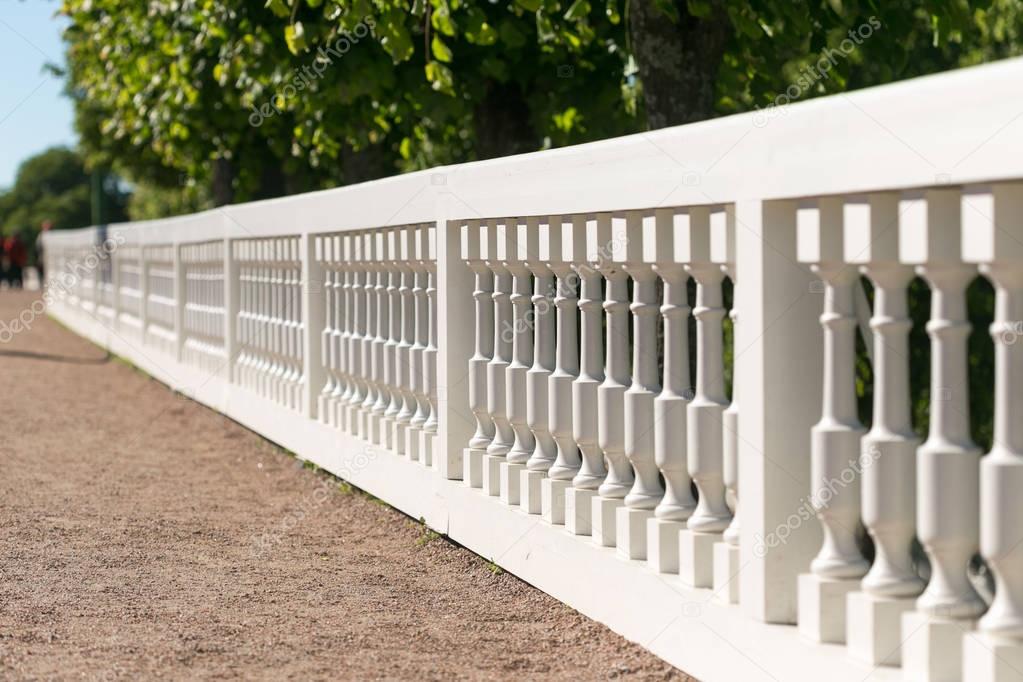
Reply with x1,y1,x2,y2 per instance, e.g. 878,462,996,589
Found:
629,0,731,129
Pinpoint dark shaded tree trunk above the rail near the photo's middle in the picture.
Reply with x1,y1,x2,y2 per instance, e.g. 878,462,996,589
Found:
474,81,540,160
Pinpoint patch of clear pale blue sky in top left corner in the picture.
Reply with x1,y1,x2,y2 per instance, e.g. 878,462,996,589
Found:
0,0,77,188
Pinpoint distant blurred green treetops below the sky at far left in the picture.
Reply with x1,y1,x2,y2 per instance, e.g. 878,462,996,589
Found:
0,147,126,239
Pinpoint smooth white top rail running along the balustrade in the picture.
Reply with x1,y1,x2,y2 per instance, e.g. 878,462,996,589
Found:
46,58,1023,241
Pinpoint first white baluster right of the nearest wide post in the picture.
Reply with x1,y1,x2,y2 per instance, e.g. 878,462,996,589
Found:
796,198,869,643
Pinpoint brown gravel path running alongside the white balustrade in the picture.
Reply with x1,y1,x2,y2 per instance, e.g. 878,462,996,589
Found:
0,291,691,680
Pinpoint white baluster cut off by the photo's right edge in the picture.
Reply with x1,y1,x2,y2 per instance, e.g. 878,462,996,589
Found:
963,183,1023,682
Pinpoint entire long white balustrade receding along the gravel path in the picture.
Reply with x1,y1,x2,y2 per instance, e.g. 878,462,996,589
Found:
45,60,1023,680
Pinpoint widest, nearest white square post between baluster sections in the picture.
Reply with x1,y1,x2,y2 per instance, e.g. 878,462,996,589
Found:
735,200,822,623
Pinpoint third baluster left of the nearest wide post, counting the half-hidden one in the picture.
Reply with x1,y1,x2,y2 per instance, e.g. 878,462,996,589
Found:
644,209,697,574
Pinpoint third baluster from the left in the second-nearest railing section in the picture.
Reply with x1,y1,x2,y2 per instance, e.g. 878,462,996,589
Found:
500,219,536,505
